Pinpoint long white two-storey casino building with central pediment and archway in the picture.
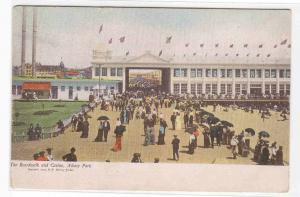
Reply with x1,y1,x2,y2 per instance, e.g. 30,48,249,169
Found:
91,45,291,96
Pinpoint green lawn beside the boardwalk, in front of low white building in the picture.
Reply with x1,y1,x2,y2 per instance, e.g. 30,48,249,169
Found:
12,101,86,134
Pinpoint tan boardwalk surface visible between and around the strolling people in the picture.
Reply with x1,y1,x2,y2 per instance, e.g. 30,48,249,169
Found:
12,104,289,164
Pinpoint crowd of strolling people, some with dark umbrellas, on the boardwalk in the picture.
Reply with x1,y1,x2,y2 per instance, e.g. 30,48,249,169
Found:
31,93,289,165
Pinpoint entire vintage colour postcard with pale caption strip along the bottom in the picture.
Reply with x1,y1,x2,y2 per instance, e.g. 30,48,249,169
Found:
11,6,292,192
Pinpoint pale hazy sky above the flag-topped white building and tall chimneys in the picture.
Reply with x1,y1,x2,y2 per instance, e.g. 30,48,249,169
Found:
12,6,291,68
